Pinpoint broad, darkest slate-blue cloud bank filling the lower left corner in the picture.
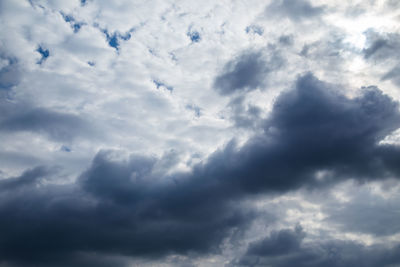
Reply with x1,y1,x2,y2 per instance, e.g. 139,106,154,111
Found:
0,153,255,266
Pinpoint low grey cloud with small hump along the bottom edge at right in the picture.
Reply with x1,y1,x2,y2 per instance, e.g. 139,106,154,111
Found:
231,228,400,267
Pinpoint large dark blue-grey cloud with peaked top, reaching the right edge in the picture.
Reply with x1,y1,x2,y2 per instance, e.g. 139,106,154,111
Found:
212,74,400,192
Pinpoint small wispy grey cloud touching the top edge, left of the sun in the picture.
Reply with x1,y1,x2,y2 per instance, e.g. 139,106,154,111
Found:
266,0,325,21
